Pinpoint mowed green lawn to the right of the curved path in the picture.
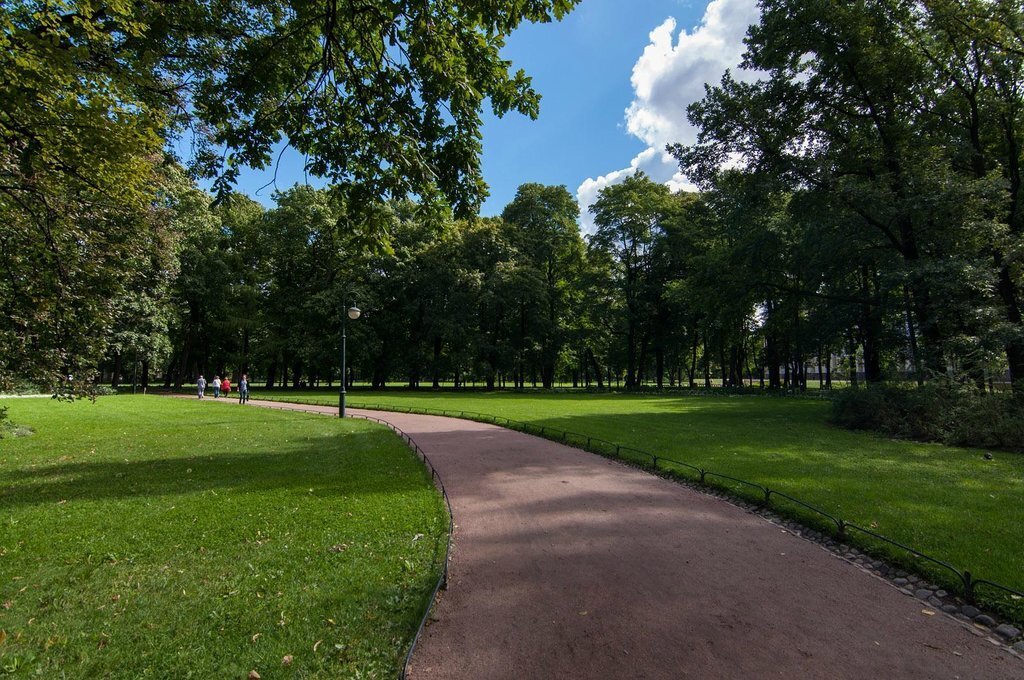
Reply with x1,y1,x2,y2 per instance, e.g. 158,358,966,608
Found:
263,391,1024,615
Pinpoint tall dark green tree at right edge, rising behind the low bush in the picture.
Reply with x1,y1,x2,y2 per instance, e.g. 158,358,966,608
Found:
673,0,1024,391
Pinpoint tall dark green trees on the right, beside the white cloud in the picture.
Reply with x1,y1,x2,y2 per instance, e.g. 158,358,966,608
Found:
672,0,1024,393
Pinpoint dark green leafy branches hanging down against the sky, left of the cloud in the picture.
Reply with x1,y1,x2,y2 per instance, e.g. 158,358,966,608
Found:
179,0,577,216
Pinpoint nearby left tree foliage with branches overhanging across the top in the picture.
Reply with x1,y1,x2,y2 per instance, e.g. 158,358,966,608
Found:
0,0,578,388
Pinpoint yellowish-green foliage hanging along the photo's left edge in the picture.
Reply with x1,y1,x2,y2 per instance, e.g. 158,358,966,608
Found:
0,0,174,393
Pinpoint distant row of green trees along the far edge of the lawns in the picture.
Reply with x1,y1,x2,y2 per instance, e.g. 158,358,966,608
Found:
81,174,921,388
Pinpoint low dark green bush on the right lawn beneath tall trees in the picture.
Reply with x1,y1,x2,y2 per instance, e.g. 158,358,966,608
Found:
833,381,1024,451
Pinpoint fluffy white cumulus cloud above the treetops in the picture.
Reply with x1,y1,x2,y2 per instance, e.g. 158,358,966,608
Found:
577,0,758,233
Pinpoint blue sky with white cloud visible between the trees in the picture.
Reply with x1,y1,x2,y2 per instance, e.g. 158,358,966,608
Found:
220,0,757,231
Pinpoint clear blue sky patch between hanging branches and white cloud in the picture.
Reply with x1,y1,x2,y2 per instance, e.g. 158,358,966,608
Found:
482,0,703,215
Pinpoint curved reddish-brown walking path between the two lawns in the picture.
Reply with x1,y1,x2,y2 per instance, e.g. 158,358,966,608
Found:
253,401,1024,680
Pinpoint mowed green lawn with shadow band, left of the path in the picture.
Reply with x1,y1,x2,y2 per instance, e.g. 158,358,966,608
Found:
0,396,447,678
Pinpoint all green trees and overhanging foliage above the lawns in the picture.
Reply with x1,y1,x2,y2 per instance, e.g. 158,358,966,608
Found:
8,0,1024,399
